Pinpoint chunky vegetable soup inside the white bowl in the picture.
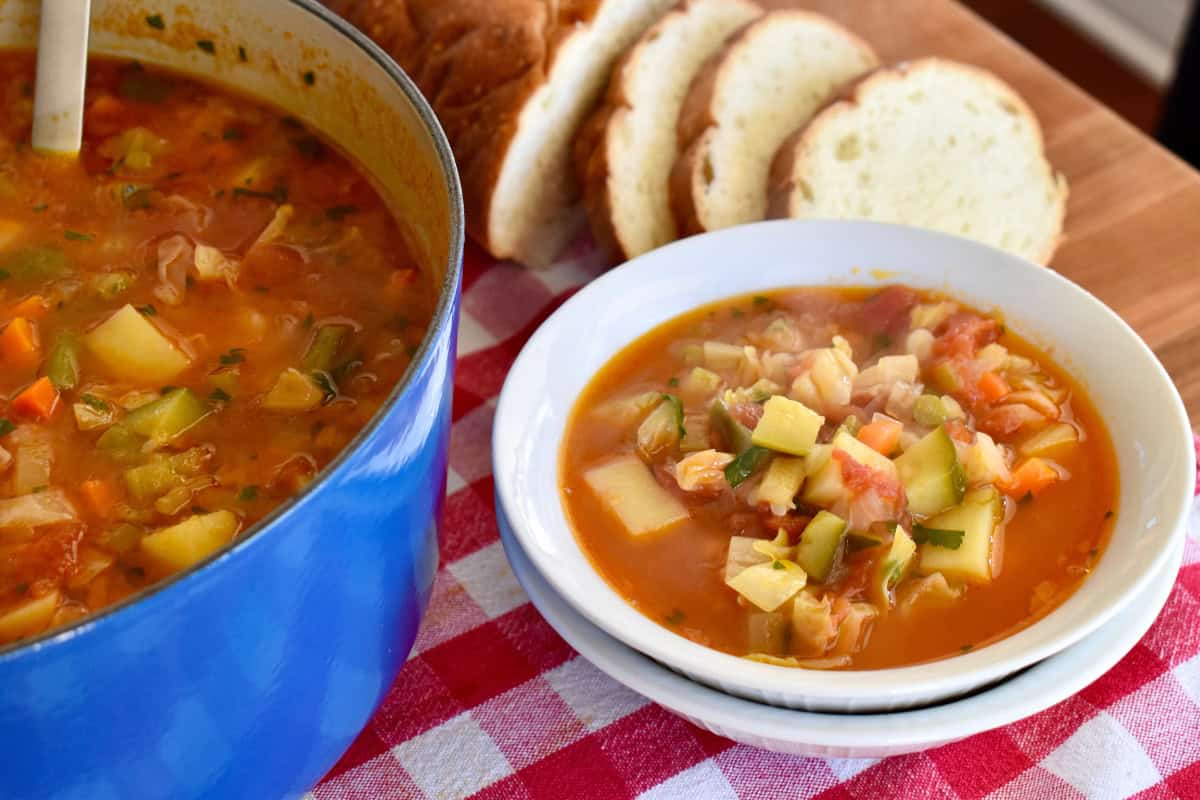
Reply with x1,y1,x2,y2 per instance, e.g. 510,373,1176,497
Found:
560,285,1117,669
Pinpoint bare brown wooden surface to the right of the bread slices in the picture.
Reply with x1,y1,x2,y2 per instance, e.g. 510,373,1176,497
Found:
763,0,1200,422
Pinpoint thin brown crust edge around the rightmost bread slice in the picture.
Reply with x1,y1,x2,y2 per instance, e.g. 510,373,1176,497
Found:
768,56,1069,264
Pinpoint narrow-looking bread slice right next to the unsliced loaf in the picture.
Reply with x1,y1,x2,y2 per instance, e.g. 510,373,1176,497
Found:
576,0,762,260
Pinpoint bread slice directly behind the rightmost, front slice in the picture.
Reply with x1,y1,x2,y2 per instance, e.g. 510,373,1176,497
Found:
671,11,877,234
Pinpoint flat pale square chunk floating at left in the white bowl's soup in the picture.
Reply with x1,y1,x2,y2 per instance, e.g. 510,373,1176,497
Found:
583,456,691,536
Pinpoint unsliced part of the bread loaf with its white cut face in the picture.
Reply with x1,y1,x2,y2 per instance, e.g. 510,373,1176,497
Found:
325,0,674,266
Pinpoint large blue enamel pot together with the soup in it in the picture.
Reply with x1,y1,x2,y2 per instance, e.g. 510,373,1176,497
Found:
0,0,463,798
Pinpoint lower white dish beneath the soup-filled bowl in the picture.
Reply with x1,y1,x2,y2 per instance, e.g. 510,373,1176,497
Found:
500,516,1183,758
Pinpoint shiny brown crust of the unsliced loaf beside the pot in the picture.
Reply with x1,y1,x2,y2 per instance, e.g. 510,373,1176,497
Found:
325,0,604,255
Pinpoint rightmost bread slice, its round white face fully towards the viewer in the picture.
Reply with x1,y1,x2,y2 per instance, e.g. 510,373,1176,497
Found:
772,59,1067,264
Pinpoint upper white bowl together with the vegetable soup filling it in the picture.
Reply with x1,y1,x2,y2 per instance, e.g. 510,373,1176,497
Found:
493,222,1194,711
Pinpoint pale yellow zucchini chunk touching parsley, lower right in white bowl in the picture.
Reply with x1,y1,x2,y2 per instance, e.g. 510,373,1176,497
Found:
920,486,1004,583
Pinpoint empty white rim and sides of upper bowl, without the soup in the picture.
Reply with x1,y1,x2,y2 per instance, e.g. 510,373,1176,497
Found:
493,221,1195,711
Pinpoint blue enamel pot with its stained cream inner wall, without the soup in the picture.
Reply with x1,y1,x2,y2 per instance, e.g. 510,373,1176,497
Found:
0,0,463,800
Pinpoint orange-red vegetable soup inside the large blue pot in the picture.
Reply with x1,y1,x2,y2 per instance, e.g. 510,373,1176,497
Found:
0,52,434,644
